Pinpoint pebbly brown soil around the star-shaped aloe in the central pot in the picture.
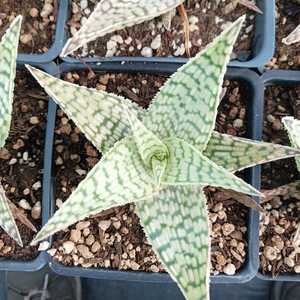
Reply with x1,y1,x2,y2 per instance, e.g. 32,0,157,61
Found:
49,71,248,274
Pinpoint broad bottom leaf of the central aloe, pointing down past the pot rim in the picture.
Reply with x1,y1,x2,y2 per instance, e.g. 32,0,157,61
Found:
136,187,210,300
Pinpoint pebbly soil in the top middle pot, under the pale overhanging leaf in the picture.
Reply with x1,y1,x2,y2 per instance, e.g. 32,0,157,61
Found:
68,0,255,61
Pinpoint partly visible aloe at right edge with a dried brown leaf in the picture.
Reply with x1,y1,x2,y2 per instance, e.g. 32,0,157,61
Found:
264,117,300,242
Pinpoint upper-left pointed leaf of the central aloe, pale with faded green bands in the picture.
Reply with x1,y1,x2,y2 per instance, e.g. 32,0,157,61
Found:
26,65,139,152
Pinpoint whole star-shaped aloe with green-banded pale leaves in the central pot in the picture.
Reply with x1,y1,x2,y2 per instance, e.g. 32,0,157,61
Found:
28,18,300,300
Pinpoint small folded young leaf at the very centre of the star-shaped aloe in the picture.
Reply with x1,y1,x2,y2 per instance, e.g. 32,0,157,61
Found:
124,107,169,185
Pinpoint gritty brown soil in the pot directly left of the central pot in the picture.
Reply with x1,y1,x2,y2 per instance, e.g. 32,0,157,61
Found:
0,71,48,260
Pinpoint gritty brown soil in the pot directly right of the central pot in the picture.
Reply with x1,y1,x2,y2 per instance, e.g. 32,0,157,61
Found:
260,86,300,276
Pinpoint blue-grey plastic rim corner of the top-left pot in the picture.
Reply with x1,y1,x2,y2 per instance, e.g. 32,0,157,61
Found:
18,0,69,63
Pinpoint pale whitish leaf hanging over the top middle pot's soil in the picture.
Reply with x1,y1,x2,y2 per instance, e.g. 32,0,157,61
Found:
61,0,184,57
